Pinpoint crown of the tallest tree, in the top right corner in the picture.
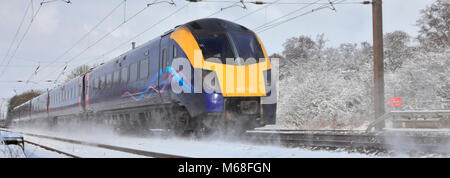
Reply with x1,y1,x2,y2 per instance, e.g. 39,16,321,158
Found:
417,0,450,50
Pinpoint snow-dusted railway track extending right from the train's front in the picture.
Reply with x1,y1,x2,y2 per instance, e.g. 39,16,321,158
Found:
245,130,450,155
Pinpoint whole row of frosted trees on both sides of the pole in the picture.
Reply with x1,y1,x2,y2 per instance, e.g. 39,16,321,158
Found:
272,0,450,129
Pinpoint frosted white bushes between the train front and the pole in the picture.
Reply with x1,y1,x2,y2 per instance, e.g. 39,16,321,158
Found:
273,35,372,129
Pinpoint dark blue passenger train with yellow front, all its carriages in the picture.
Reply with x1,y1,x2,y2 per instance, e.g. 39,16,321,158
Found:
8,18,277,133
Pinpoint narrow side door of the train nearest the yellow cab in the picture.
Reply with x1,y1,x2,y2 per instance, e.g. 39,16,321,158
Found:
159,36,172,103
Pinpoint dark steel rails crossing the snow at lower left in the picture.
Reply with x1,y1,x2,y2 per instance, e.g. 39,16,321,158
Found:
0,129,186,158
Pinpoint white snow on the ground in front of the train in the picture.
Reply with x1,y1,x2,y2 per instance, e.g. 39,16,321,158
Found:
7,126,384,158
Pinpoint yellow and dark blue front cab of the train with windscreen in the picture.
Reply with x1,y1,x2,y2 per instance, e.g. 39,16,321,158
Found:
170,19,276,130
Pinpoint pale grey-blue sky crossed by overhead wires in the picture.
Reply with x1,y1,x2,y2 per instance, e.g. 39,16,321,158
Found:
0,0,434,102
